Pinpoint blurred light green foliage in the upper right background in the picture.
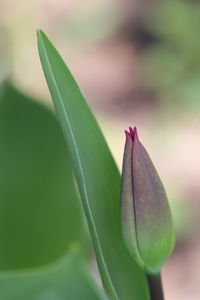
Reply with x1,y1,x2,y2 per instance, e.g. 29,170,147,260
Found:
143,0,200,109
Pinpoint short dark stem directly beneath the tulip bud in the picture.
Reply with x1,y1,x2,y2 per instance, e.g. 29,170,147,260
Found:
147,274,164,300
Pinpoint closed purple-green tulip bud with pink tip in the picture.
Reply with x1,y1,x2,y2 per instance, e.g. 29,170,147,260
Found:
121,128,174,273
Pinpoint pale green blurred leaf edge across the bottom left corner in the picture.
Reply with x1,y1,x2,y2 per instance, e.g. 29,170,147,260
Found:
0,248,107,300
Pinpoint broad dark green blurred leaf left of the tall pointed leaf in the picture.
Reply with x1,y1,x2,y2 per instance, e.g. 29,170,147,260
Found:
0,83,84,270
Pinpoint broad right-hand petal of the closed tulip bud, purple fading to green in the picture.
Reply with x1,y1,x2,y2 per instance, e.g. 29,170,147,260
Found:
132,134,174,272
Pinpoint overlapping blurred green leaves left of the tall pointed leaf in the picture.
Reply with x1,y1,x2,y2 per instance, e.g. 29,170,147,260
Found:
0,82,106,300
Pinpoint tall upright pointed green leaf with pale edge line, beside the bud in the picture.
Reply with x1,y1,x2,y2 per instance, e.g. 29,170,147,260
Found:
38,31,149,300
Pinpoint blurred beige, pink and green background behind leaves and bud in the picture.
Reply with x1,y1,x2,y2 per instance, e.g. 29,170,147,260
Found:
0,0,200,300
